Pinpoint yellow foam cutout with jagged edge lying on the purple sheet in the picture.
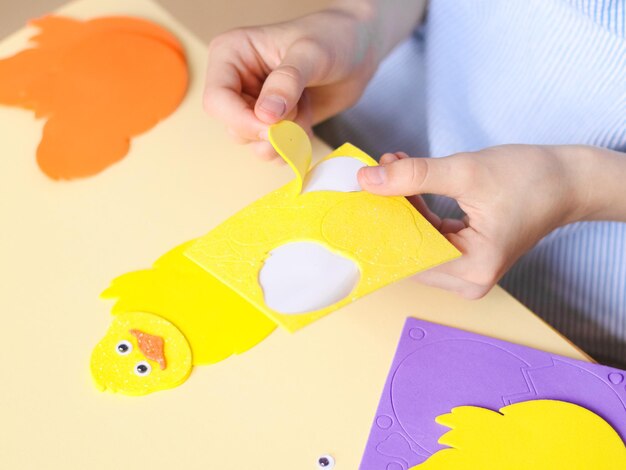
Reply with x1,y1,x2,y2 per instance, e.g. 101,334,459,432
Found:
412,400,626,470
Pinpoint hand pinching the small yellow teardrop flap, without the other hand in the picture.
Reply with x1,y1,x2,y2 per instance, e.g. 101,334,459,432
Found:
204,9,376,159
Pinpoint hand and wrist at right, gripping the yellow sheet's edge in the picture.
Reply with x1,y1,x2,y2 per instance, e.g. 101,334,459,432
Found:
359,145,626,298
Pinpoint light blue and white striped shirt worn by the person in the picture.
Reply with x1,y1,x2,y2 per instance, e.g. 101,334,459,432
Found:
321,0,626,365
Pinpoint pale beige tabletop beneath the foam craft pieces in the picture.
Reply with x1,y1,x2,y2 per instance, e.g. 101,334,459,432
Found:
0,0,583,470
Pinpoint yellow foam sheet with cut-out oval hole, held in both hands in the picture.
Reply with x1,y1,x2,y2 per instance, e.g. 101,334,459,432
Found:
186,122,460,331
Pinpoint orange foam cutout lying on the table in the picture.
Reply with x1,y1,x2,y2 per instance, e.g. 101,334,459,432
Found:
0,16,188,179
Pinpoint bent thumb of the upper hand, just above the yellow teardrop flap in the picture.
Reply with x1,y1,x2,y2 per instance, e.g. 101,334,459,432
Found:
254,41,315,124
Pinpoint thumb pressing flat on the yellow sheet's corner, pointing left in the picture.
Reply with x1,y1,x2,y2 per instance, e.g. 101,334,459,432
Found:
358,156,469,198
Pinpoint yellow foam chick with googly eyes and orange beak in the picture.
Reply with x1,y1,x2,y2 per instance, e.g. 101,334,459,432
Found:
91,240,276,395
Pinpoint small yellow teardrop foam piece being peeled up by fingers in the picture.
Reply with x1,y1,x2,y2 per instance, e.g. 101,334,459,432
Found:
268,121,313,192
